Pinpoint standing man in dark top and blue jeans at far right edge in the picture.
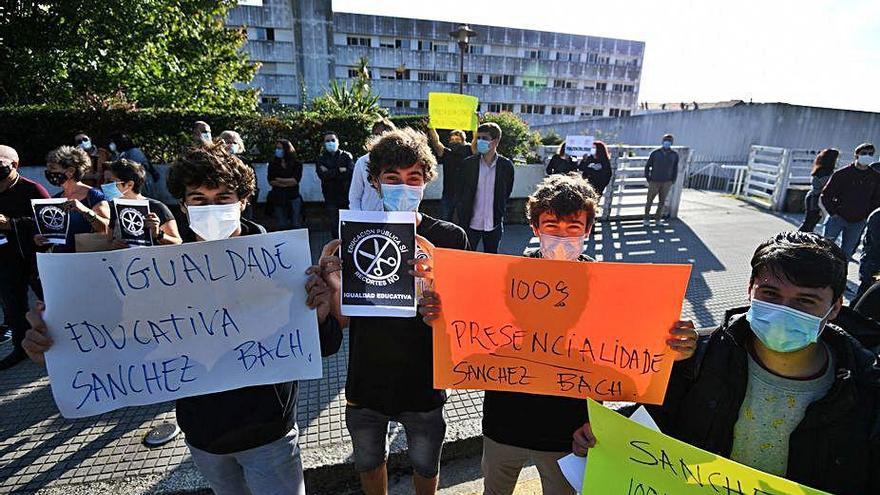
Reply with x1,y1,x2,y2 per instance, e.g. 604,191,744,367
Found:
820,143,880,260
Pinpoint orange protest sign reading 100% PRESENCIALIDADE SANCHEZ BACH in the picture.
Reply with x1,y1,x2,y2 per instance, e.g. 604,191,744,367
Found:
432,249,691,404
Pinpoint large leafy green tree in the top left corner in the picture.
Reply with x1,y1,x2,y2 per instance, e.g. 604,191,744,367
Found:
0,0,258,111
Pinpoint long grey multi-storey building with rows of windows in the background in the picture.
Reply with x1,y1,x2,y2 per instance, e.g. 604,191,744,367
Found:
229,0,645,124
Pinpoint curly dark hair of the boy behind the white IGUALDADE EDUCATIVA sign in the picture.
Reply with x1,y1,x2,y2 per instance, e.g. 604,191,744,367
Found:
167,144,257,200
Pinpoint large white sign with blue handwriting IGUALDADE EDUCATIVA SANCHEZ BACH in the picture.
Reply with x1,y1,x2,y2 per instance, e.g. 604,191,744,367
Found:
37,229,321,418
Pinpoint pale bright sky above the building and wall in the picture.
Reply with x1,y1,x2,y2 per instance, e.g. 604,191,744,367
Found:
333,0,880,112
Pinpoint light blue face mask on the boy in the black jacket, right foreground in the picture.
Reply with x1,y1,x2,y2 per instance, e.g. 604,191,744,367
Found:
746,299,834,352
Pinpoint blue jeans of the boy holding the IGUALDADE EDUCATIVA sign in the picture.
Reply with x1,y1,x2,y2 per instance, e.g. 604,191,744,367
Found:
187,427,306,495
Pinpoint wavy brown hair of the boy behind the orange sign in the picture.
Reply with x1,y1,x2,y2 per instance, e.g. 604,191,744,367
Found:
526,172,599,227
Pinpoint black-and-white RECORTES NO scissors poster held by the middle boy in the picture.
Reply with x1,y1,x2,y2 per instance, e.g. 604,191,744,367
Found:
339,210,417,317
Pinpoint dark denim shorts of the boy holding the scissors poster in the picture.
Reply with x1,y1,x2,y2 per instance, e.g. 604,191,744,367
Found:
345,406,446,478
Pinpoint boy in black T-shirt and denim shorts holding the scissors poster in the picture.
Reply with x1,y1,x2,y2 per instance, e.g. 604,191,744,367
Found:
320,128,467,495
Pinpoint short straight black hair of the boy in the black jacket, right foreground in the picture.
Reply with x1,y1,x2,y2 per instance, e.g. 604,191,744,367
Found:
749,232,847,299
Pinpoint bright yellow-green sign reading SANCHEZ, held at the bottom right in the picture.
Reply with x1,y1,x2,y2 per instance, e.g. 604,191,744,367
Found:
582,400,828,495
